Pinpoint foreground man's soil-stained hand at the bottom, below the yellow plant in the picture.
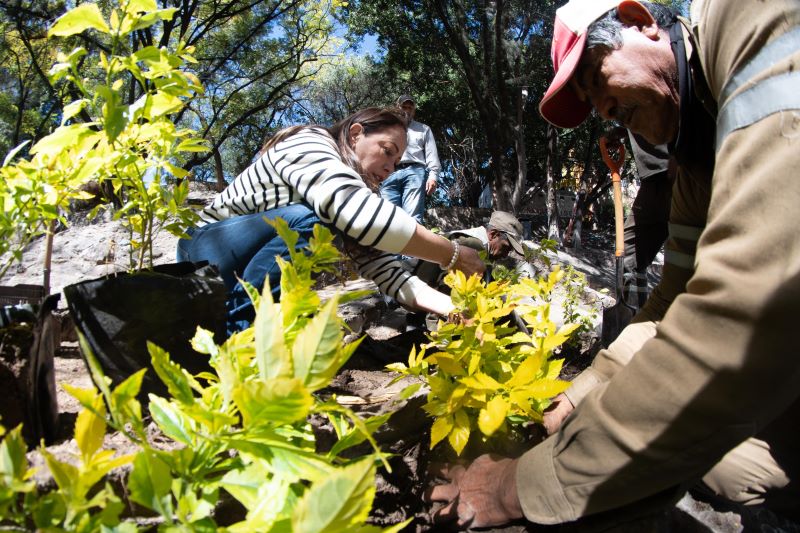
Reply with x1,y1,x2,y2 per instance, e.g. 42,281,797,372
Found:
425,454,523,529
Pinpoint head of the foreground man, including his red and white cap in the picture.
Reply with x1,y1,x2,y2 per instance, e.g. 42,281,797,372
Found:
539,0,679,144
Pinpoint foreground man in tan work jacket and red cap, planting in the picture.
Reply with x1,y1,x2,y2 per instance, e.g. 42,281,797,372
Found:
427,0,800,529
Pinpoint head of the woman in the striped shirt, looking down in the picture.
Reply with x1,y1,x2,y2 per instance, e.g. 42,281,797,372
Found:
328,107,408,190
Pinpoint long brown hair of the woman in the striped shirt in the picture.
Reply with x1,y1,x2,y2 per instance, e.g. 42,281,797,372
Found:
259,107,408,190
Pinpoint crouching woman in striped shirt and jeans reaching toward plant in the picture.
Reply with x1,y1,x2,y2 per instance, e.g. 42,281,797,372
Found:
178,108,485,333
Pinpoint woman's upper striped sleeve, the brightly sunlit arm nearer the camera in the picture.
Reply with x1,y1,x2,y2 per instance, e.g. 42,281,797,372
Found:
264,129,417,253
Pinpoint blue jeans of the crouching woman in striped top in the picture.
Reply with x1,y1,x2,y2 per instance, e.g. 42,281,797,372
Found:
177,204,319,335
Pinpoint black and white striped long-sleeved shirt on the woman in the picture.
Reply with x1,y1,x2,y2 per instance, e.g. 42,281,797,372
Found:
200,128,425,304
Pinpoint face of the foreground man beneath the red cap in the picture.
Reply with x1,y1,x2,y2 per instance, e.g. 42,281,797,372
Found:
570,26,679,144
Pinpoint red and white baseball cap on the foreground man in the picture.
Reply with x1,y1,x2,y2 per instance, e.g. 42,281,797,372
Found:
539,0,622,128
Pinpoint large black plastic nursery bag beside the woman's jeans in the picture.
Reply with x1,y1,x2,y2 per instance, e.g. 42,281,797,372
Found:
64,262,226,398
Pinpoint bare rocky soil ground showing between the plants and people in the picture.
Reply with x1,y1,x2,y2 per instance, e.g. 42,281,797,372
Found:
0,197,800,532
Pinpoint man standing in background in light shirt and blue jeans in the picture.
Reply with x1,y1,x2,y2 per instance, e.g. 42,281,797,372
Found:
380,94,442,224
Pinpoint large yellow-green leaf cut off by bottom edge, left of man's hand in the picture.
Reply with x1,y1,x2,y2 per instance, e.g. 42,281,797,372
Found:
292,457,375,533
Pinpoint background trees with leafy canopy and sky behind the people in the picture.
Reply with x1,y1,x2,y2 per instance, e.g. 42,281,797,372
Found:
0,0,686,215
